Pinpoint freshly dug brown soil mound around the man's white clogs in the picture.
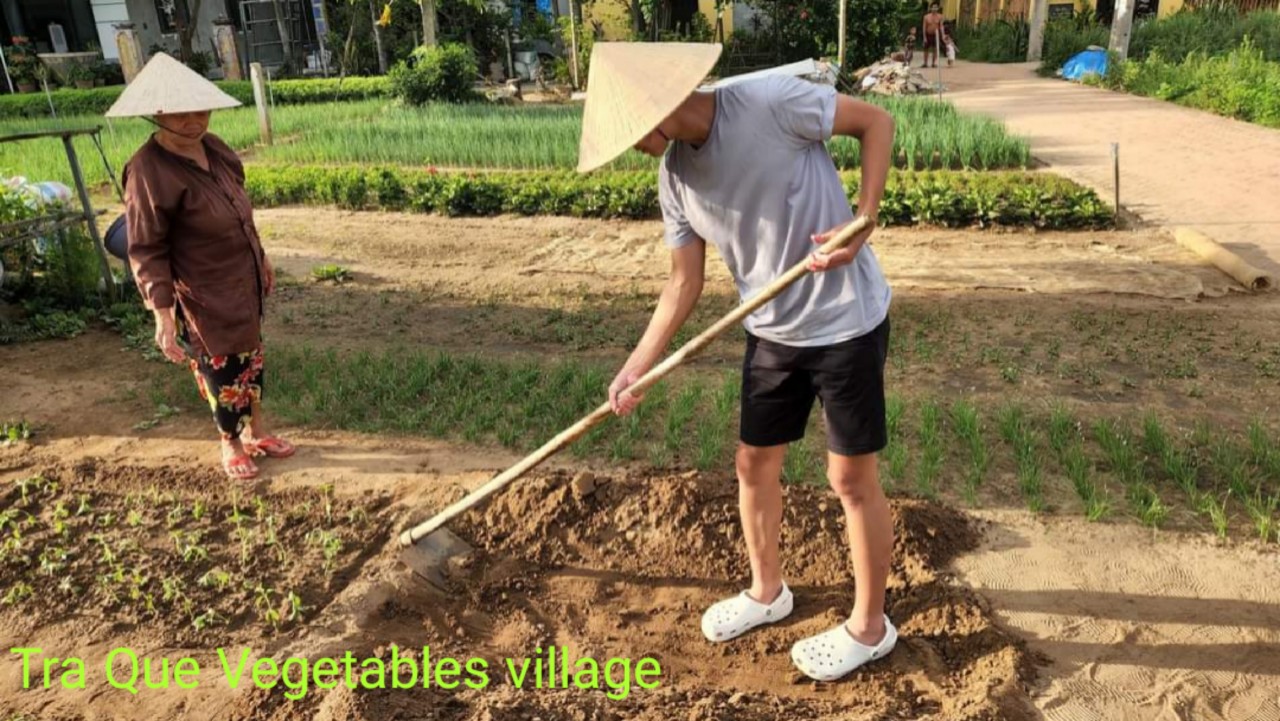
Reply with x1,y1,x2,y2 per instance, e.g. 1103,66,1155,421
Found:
227,473,1037,721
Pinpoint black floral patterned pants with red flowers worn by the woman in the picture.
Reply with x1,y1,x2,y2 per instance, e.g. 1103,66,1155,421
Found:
175,311,264,441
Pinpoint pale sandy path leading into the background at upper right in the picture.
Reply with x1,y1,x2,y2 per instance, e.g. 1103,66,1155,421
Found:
931,63,1280,279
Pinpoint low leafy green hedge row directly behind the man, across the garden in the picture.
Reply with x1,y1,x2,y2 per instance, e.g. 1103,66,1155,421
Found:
247,165,1112,229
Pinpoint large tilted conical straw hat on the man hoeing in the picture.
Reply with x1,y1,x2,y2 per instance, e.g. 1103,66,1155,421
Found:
577,42,722,173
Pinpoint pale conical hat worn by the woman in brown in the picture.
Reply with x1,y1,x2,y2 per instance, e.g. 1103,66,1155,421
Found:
106,53,241,118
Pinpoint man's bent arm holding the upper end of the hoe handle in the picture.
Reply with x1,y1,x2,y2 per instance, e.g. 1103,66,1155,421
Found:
810,95,893,270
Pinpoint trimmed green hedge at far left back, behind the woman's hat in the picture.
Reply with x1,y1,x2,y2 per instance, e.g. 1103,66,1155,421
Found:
0,77,390,119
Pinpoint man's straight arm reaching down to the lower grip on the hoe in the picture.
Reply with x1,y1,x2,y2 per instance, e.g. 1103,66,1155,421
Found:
609,239,707,415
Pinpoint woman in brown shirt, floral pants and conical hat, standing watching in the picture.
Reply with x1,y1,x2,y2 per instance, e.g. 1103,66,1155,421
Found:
106,53,294,480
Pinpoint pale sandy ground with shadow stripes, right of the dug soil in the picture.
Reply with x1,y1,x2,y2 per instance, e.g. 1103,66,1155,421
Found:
955,512,1280,721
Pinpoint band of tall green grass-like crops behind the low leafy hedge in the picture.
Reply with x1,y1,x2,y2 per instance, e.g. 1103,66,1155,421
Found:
0,96,1030,184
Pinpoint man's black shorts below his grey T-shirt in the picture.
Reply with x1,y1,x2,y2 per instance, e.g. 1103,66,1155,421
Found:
739,318,888,456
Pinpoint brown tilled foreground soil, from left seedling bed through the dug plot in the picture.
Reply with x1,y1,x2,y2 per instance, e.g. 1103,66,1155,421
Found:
0,453,1034,720
